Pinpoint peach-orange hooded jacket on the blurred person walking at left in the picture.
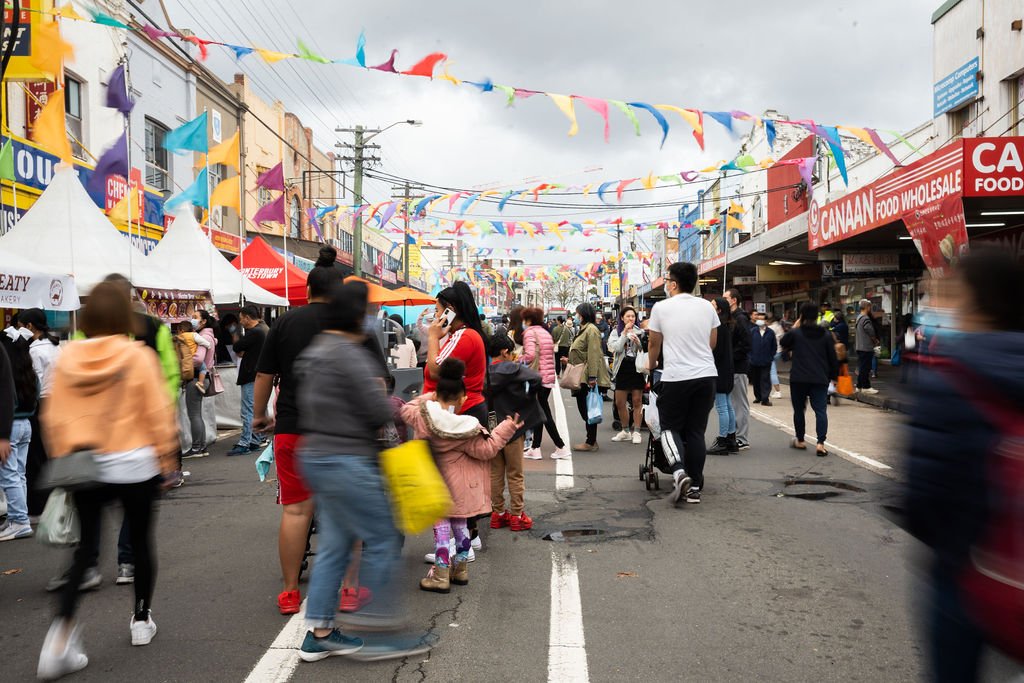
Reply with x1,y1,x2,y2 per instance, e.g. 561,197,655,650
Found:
40,335,178,473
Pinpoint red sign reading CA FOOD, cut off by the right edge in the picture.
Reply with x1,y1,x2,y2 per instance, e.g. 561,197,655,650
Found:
964,137,1024,197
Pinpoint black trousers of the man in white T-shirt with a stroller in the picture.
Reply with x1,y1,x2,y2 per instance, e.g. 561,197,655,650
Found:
655,377,716,488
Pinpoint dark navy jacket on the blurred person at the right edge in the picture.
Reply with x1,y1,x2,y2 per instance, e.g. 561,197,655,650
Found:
905,332,1024,572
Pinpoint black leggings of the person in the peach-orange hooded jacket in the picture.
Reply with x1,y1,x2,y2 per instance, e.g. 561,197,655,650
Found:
58,477,160,618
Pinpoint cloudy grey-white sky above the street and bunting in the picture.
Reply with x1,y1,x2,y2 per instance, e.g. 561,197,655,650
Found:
157,0,938,262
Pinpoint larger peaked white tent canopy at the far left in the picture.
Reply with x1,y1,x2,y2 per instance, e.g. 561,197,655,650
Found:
0,164,176,296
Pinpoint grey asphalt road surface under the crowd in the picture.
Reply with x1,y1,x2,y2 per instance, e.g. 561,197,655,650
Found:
0,387,1021,682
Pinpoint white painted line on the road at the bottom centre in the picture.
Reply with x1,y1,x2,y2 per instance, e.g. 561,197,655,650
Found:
548,551,590,683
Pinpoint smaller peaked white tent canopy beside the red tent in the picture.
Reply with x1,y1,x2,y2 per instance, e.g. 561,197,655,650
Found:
146,205,288,306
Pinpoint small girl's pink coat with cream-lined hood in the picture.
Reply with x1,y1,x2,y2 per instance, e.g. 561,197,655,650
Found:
401,393,516,517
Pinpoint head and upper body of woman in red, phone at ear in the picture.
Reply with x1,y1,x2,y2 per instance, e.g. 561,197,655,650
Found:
423,282,487,428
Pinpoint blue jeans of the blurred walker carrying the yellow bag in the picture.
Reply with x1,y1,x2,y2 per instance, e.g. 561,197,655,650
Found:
299,451,403,629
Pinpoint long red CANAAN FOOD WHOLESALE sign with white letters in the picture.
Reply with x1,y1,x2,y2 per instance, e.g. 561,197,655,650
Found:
807,140,964,251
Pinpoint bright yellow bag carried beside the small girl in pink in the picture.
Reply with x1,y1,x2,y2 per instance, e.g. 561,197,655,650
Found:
380,439,452,535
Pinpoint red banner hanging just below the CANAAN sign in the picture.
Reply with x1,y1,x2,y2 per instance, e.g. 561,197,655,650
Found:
902,195,968,278
